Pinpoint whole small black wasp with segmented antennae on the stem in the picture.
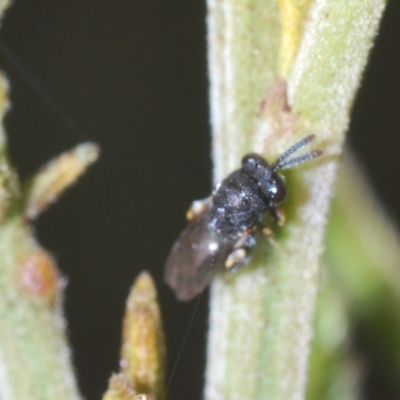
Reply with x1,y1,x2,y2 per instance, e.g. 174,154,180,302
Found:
165,135,322,301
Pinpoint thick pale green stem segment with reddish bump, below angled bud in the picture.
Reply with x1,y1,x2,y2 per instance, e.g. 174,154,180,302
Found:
0,218,80,400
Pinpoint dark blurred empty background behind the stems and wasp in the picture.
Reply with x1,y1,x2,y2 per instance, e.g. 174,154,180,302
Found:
0,0,400,400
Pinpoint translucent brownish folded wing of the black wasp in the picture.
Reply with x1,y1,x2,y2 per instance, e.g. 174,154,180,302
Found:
164,208,235,301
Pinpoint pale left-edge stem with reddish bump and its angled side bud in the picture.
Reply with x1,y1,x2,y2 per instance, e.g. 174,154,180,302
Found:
0,1,98,400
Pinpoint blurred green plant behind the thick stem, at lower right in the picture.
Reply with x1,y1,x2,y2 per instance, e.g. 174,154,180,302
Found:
307,152,400,400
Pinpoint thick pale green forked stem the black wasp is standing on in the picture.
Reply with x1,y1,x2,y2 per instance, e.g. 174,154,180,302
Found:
205,0,385,400
